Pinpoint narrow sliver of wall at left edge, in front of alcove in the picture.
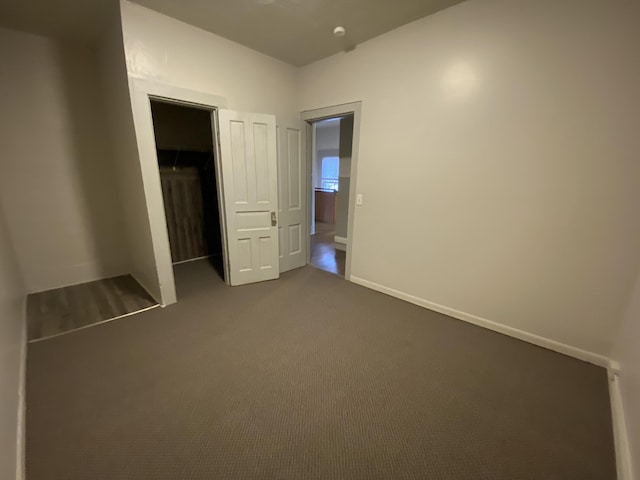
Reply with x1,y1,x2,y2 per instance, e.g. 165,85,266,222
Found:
0,198,26,479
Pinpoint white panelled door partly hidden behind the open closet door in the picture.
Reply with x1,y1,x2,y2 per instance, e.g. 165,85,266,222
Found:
276,121,307,273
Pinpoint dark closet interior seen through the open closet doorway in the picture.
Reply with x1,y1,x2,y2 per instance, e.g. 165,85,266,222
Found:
151,100,223,282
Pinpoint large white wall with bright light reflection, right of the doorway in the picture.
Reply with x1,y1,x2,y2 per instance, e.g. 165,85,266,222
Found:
299,0,640,355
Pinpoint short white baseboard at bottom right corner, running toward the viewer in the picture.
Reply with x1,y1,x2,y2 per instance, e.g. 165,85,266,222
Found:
609,370,633,480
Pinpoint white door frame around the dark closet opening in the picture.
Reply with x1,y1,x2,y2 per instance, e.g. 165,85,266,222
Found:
129,77,229,306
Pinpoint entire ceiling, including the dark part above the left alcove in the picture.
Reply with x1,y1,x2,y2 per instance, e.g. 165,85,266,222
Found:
0,0,463,66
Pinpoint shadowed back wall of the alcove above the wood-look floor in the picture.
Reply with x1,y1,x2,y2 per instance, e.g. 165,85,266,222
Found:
0,29,126,292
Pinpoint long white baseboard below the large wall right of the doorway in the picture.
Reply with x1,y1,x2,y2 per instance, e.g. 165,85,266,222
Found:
351,275,610,368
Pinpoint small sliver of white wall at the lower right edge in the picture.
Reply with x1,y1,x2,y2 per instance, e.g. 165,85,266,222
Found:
611,275,640,475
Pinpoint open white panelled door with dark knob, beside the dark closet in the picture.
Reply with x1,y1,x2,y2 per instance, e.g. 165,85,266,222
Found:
218,110,280,285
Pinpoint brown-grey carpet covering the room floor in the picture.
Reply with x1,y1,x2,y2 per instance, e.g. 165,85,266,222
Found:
27,262,616,480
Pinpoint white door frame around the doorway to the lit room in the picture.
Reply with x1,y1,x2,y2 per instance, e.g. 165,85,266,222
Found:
300,101,362,281
